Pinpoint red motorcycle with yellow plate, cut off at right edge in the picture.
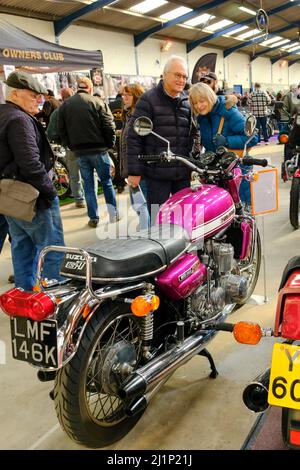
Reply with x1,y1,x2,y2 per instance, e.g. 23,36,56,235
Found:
243,256,300,449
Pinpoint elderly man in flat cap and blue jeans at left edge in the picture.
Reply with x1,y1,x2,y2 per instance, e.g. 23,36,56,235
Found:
0,72,64,291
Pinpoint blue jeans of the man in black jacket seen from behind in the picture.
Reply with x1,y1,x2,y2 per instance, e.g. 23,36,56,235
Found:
77,152,118,219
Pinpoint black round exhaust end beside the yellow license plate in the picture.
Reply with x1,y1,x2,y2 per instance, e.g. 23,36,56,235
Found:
243,368,271,413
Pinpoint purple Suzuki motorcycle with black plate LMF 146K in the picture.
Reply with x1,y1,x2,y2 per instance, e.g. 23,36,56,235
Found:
0,118,267,447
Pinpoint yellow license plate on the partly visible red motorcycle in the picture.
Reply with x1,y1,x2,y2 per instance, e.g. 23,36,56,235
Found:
268,343,300,410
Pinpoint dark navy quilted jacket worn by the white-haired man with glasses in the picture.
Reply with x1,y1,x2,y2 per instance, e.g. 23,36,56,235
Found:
127,81,197,180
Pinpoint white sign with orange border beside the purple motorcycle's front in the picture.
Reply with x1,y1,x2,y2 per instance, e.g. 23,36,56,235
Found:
250,168,278,215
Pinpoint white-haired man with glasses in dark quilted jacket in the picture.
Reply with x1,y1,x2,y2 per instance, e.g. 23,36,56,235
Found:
127,56,197,224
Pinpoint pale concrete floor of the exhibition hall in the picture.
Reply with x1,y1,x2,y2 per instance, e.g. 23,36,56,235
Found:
0,144,300,450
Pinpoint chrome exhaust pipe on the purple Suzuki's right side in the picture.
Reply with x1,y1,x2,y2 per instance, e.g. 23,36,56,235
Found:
119,331,217,404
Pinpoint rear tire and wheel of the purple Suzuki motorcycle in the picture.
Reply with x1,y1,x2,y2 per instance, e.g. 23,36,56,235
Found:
54,303,144,448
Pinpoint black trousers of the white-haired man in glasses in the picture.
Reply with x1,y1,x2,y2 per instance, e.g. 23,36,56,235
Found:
145,177,190,225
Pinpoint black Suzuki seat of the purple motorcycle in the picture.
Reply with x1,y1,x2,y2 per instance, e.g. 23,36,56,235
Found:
61,225,190,284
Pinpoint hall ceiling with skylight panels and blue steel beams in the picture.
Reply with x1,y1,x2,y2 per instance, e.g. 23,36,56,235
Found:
0,0,300,64
